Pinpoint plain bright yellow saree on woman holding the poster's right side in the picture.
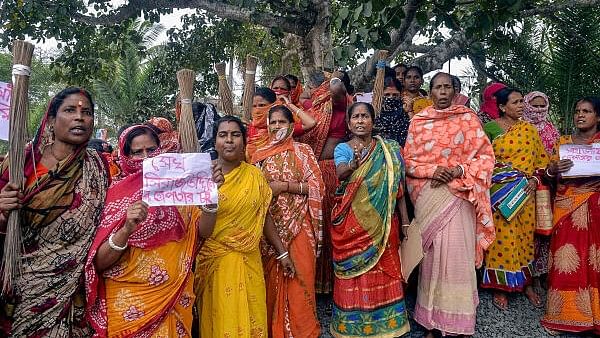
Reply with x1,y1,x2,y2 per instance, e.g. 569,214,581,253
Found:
196,162,272,338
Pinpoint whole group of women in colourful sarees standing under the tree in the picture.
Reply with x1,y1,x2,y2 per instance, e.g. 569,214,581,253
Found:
0,61,600,337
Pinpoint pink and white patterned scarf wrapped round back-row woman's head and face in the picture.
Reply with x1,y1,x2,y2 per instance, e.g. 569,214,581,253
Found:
523,91,560,153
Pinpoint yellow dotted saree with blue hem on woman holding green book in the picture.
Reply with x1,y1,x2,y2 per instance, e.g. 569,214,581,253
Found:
481,121,548,291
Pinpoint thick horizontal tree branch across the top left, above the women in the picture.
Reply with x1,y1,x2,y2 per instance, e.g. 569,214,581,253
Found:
73,0,315,36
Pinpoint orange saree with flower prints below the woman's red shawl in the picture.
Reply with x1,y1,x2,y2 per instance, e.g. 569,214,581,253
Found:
103,206,200,337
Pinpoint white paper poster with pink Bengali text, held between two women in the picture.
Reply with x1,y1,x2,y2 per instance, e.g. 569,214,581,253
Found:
142,153,219,206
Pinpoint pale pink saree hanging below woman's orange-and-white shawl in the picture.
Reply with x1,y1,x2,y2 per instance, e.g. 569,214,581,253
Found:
411,184,479,335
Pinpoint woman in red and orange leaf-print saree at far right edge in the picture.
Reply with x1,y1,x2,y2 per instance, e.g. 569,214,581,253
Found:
542,98,600,335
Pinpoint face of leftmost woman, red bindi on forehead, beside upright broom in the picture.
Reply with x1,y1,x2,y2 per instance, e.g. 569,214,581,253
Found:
49,93,94,146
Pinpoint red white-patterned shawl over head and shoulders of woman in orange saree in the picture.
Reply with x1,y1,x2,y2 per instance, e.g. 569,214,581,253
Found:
85,125,186,336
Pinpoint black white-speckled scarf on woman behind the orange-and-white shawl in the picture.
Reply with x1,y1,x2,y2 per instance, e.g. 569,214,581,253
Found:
375,97,410,147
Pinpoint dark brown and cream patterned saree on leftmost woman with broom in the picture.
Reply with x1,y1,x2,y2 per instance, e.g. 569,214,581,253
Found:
1,149,109,337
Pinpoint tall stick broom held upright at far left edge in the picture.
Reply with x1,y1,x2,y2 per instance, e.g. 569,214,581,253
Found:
2,40,33,295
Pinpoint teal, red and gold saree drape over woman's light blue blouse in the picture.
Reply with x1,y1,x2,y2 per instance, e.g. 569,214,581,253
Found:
331,136,404,279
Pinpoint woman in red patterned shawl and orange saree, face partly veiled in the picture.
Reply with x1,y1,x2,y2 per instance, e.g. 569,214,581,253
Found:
85,124,222,337
